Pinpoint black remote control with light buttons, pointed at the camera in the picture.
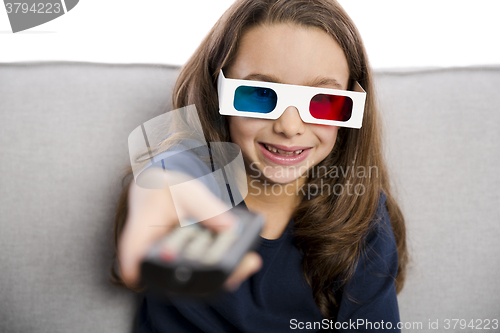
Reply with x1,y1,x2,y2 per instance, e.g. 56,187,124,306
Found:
141,208,264,297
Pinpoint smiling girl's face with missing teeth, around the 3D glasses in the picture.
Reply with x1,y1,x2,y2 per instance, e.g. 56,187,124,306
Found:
224,24,349,184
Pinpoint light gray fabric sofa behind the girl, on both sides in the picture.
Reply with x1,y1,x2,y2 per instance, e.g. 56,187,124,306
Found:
0,62,500,333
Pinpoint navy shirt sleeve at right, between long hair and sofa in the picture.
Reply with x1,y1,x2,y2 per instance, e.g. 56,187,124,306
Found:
337,193,401,332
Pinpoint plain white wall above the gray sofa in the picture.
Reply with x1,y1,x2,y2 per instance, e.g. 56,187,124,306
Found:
0,0,500,68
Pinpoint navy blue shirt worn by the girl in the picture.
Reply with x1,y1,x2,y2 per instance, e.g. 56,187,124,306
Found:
132,139,400,333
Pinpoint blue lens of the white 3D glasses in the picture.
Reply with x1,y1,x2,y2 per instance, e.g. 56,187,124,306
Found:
233,86,278,113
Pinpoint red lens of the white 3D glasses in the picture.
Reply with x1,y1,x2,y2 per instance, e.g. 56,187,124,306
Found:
309,94,352,121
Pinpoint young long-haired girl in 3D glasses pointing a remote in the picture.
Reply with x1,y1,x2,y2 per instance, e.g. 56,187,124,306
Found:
109,0,407,332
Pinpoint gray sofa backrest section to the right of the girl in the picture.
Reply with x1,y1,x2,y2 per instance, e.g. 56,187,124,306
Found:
377,67,500,332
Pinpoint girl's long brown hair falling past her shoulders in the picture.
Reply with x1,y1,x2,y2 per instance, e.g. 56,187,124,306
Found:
112,0,408,318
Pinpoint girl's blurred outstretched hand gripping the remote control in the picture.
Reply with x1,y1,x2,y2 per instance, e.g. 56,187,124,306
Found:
118,168,262,290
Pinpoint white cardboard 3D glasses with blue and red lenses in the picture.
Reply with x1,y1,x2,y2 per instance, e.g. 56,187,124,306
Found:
217,70,366,128
